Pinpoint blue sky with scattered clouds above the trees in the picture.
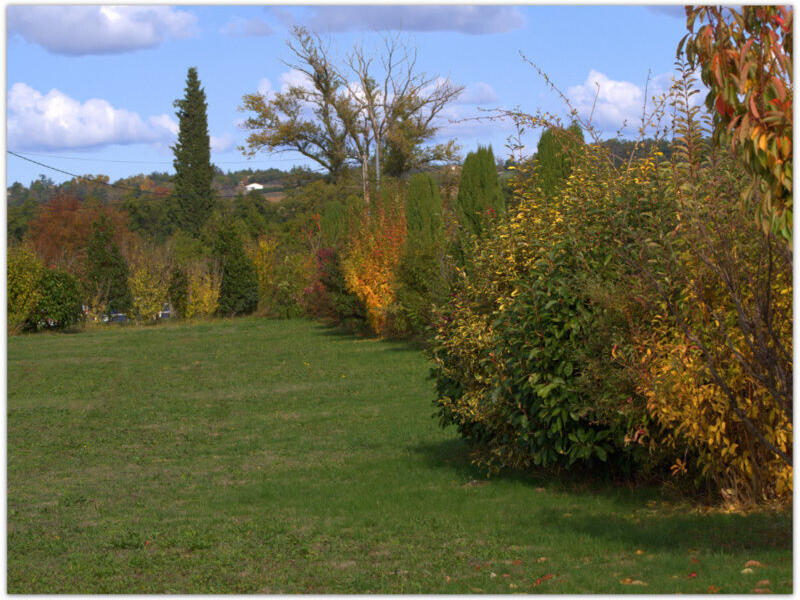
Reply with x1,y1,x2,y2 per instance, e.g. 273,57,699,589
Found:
5,4,686,185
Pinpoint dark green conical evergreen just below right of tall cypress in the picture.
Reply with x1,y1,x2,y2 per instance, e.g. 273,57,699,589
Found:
214,223,258,317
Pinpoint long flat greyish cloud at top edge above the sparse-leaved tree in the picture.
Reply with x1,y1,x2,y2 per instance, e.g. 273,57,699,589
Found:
308,5,525,35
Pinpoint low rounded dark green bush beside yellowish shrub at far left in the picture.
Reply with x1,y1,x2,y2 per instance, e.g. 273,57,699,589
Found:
26,269,83,331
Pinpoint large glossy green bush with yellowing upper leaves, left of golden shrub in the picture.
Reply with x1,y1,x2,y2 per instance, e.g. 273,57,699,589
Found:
432,135,647,471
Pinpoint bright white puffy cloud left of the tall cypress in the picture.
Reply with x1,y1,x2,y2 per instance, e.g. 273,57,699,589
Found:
7,83,178,150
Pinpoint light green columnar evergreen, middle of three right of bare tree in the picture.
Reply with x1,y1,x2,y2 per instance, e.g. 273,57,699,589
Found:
456,146,505,235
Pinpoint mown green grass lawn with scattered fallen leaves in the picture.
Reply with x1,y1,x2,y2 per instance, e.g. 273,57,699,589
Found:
7,318,792,594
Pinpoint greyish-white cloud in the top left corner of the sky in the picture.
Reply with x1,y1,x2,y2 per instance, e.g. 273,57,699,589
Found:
7,5,197,55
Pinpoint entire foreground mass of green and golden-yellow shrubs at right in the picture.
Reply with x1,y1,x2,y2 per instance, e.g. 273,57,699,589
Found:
432,58,793,502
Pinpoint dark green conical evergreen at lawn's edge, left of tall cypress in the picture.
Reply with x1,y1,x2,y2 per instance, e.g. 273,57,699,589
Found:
86,215,133,312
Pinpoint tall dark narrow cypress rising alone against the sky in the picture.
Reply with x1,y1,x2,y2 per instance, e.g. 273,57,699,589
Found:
170,67,214,236
